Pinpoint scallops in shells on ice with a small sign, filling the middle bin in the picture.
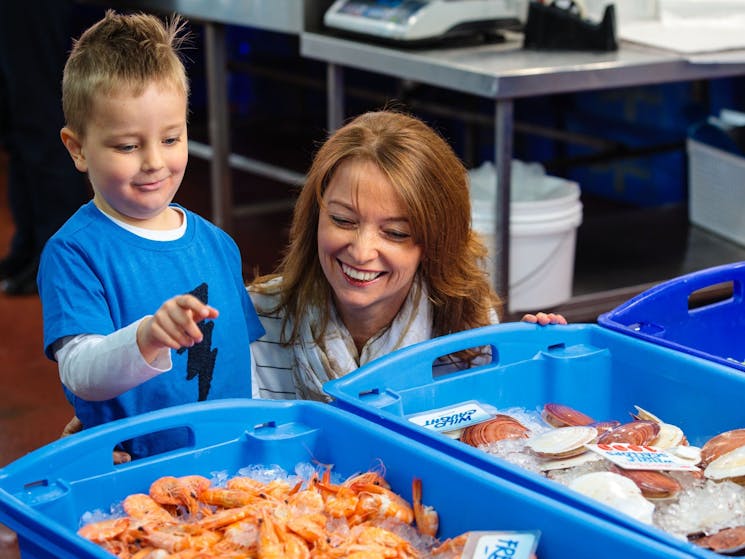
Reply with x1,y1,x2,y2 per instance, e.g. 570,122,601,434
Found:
460,402,745,555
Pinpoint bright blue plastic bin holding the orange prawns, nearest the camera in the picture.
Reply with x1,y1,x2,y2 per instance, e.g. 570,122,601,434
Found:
0,400,686,559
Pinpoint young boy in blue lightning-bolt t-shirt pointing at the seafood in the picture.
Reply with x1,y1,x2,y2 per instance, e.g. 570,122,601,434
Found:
38,11,263,458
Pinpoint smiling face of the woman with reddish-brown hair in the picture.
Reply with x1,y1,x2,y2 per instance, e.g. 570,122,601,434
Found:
318,160,422,327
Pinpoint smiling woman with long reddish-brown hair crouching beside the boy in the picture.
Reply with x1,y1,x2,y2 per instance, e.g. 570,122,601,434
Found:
249,111,566,401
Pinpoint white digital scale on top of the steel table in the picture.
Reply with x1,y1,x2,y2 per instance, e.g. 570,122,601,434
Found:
323,0,527,43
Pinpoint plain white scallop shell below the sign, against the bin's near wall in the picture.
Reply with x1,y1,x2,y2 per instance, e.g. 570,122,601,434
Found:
569,472,654,524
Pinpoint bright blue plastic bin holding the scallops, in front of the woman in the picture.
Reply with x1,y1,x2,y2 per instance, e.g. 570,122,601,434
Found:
324,323,745,558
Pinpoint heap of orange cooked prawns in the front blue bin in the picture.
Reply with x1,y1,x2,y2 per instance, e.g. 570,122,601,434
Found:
78,468,535,559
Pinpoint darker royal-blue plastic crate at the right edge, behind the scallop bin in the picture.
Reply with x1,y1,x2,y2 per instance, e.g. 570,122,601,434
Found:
598,262,745,372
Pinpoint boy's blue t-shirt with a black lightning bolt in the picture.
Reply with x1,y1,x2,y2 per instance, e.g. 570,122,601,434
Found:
38,202,264,457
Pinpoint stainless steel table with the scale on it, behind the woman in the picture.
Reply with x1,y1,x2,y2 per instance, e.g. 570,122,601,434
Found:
300,31,745,306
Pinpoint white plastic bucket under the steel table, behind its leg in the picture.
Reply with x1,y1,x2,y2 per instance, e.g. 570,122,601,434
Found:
472,176,582,312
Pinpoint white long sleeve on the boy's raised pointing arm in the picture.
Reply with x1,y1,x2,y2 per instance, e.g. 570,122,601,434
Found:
55,317,172,401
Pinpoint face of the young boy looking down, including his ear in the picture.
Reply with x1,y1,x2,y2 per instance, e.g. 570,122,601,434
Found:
62,83,188,229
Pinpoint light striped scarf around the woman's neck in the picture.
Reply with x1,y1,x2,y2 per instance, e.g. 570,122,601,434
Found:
292,279,432,402
